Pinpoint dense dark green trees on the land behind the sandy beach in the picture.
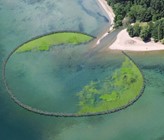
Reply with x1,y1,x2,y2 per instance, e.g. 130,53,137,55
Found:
107,0,164,42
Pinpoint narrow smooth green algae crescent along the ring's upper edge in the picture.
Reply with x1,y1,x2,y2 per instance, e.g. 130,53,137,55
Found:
16,32,93,52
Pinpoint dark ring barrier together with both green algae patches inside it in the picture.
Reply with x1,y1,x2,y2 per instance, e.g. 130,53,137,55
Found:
3,32,145,117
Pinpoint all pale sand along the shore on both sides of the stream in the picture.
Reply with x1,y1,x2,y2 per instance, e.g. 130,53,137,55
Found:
96,0,164,51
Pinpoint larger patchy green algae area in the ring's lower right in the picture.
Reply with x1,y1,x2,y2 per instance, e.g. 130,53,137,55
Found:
77,57,144,114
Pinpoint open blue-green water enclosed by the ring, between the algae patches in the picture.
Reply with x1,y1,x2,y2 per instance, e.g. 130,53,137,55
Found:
6,43,121,113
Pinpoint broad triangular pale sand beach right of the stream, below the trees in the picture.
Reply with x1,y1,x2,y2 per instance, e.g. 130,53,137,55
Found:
109,29,164,51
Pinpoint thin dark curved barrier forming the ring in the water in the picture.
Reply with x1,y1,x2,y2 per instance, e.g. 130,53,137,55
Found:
2,32,145,117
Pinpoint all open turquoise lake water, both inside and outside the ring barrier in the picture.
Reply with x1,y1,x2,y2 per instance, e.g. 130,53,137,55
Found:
0,0,164,140
